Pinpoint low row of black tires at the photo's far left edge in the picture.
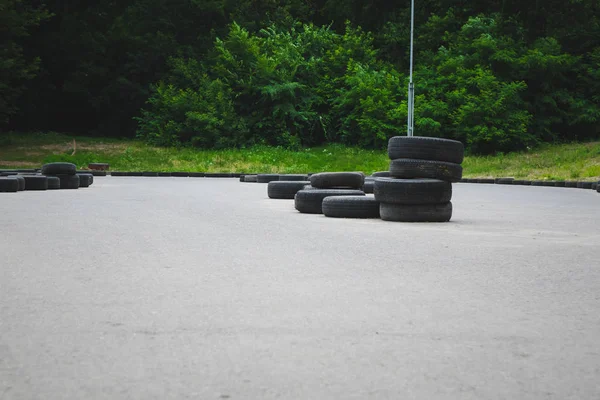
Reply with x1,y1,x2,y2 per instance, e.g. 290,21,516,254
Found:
0,163,94,192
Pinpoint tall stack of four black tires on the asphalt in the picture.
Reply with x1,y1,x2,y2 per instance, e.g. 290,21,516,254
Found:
373,136,464,222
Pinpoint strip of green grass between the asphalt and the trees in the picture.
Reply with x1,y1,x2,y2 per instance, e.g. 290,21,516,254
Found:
0,132,600,180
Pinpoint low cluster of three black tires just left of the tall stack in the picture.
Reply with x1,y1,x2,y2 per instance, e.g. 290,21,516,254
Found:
294,172,374,218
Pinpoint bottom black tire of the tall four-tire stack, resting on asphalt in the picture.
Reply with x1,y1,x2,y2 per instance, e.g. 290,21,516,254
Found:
379,202,452,222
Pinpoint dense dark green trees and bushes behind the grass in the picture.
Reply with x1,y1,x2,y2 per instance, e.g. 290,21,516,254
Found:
0,0,600,153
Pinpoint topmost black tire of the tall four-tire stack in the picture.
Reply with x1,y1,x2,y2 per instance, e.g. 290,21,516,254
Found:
388,136,465,164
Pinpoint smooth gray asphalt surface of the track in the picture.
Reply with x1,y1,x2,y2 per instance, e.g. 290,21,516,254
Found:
0,177,600,400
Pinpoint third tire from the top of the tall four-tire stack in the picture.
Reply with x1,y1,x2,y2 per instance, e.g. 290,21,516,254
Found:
373,178,452,204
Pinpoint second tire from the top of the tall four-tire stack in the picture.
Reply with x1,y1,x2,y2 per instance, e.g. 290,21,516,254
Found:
390,158,462,182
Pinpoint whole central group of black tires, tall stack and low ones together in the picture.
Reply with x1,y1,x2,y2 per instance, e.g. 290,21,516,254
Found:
246,136,464,222
